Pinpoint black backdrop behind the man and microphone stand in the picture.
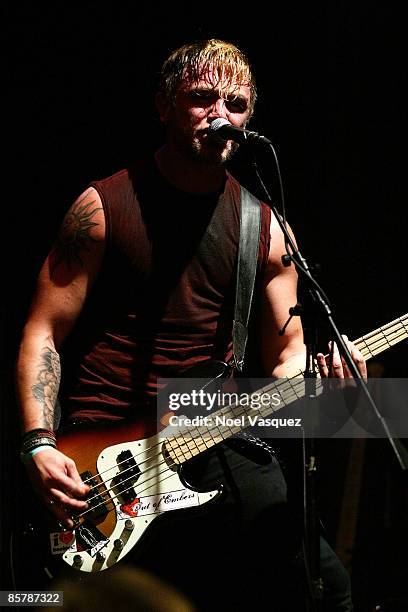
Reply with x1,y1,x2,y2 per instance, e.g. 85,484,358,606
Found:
1,1,408,610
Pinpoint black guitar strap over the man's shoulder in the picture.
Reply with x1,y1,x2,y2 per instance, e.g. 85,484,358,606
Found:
232,186,261,372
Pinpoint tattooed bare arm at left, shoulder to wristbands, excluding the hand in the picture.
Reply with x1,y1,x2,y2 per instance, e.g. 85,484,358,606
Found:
17,188,105,431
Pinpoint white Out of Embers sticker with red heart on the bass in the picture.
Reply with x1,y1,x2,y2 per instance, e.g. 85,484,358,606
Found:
117,489,199,519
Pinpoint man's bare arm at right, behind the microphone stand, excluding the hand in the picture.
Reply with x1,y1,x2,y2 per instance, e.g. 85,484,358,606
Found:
259,215,306,377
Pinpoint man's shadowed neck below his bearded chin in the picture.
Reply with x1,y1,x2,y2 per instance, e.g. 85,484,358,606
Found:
155,144,225,194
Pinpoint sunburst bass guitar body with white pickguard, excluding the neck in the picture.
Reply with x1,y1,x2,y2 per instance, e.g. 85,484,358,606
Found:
50,423,222,572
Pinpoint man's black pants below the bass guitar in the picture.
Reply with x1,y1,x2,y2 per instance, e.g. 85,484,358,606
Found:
129,445,352,612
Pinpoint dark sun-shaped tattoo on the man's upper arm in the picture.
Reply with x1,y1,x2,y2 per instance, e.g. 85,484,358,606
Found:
50,196,102,274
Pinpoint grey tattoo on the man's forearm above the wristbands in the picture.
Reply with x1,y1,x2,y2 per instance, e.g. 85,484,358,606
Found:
31,346,61,429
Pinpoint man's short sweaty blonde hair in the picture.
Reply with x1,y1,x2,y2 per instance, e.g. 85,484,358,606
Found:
160,38,256,115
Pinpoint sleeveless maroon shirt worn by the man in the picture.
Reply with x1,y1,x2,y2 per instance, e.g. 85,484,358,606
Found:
65,163,270,420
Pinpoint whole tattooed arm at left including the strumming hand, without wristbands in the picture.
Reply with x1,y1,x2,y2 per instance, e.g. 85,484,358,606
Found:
16,189,105,527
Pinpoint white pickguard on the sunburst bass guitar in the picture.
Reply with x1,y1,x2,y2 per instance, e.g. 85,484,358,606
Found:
62,436,221,572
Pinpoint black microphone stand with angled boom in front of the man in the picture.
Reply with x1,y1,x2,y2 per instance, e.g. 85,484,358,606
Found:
248,141,408,612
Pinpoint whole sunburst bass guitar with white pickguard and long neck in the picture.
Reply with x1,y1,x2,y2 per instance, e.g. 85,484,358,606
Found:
43,314,408,572
